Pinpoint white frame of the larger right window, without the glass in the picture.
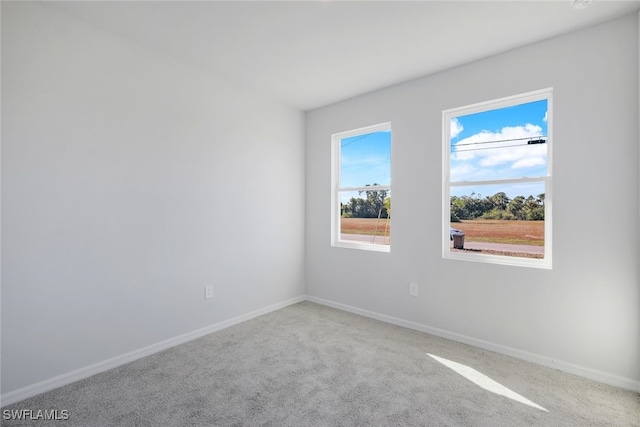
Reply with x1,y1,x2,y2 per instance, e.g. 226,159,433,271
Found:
441,88,553,269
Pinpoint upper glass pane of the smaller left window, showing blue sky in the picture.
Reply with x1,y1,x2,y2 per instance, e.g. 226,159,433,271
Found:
340,131,391,188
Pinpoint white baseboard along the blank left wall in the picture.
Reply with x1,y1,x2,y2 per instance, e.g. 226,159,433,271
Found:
0,296,306,407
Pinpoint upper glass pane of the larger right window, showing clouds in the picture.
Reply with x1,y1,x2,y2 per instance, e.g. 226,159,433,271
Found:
450,99,547,182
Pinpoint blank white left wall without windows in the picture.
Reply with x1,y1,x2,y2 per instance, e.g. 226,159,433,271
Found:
2,2,304,394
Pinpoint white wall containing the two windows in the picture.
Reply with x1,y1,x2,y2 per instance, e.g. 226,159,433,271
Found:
306,14,640,390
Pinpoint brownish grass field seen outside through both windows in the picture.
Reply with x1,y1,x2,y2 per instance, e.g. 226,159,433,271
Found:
341,218,544,246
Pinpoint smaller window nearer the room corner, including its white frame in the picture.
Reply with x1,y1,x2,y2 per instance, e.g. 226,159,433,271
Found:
331,123,391,252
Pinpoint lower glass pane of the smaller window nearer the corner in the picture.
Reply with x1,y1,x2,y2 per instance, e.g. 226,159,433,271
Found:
340,190,391,245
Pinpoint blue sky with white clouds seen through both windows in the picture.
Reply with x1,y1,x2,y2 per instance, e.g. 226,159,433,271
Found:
340,100,547,200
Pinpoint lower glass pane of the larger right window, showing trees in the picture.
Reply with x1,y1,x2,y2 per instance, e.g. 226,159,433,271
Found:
450,182,545,258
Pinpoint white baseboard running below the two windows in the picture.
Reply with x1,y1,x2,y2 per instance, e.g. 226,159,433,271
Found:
306,295,640,392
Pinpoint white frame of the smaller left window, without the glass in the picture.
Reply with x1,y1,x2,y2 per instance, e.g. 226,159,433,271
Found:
331,122,391,252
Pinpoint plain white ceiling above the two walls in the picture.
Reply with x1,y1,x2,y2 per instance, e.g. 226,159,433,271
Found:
45,0,640,111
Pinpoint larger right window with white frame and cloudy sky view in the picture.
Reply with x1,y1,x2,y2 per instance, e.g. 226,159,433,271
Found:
442,89,553,268
